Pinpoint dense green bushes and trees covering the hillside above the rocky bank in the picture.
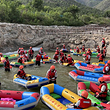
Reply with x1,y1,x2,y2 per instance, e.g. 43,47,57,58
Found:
0,0,110,26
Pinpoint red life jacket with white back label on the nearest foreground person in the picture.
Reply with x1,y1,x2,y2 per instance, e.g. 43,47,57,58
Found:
78,98,91,109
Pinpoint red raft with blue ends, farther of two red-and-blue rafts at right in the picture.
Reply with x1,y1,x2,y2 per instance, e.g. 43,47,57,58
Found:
74,62,103,73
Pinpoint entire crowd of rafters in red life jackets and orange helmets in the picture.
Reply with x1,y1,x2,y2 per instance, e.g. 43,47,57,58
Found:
0,38,110,109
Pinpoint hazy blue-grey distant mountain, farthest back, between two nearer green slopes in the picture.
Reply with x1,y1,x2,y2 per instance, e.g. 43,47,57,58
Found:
75,0,103,7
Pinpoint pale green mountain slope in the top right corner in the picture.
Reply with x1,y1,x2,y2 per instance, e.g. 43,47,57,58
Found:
95,0,110,11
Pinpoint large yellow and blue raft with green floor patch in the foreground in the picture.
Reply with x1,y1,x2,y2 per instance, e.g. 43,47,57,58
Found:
40,84,98,110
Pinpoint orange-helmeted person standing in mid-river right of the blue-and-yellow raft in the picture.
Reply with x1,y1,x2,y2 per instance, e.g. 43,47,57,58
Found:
46,65,57,84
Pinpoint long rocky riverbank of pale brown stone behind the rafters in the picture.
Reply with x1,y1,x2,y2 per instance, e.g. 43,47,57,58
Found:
0,23,110,53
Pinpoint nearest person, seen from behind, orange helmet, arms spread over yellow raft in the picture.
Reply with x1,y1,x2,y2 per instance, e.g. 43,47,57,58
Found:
66,90,97,109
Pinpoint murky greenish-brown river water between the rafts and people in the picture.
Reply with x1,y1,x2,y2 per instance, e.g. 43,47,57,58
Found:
0,48,108,110
